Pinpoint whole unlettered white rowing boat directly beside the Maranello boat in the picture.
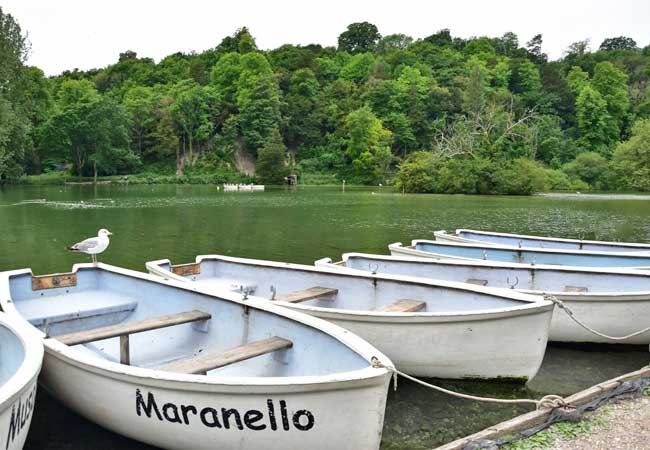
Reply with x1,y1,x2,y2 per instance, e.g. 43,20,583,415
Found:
147,255,553,379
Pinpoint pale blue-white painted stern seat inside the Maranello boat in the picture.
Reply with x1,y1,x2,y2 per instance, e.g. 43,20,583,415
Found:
22,292,138,327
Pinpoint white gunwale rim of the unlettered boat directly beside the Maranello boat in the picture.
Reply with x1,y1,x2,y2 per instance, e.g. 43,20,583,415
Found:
146,255,554,323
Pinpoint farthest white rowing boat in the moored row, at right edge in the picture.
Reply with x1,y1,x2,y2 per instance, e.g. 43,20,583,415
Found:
433,228,650,253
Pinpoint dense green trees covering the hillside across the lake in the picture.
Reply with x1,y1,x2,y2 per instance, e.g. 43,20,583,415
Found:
0,16,650,194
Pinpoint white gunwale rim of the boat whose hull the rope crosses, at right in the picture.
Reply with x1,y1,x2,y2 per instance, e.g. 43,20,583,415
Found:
322,252,650,302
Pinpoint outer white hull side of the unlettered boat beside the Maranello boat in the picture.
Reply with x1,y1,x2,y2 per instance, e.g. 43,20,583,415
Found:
296,307,553,380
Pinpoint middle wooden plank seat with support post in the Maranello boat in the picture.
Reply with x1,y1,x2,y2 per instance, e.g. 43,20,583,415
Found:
54,310,212,345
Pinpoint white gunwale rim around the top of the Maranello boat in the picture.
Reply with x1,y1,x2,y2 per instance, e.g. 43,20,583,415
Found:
0,263,392,393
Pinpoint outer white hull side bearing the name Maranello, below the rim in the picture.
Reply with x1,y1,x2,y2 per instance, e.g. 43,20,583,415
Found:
41,350,389,450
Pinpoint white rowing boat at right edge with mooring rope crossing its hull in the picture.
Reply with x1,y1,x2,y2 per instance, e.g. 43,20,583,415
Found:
315,253,650,344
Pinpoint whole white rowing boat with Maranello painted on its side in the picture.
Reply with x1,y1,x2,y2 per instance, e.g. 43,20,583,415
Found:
0,264,391,450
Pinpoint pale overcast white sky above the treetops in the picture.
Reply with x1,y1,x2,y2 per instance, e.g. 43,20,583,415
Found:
0,0,650,75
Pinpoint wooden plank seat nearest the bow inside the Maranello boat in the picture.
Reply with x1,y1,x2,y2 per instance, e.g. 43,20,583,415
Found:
158,336,293,374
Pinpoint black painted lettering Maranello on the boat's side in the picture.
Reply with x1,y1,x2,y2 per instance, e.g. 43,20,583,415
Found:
135,389,316,431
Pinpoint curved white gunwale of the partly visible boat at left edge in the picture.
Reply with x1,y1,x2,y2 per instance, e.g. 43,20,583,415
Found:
0,312,44,410
